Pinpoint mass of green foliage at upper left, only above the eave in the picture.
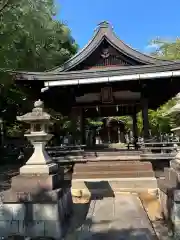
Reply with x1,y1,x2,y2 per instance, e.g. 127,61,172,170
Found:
0,0,77,71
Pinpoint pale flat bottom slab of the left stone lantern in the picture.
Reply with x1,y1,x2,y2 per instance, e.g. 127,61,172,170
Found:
20,163,58,174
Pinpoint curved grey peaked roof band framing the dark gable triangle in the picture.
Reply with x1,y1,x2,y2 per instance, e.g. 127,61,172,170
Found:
47,22,172,72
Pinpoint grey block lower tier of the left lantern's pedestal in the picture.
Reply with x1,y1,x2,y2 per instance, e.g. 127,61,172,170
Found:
0,189,72,239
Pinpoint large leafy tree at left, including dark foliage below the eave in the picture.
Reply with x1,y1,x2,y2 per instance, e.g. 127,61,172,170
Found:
0,0,77,137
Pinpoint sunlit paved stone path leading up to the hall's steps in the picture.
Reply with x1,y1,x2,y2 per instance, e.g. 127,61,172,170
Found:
65,194,157,240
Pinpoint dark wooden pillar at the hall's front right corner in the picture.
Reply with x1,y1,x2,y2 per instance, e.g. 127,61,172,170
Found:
141,97,149,139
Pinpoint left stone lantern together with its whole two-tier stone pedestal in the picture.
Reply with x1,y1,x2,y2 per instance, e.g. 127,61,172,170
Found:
0,100,72,240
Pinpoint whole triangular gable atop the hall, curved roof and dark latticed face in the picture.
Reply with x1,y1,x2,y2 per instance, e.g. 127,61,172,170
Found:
48,22,172,72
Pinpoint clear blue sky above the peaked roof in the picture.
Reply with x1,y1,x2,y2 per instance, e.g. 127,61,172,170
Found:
56,0,180,52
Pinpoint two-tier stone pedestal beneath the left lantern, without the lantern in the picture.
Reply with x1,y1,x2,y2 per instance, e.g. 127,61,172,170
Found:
0,175,73,239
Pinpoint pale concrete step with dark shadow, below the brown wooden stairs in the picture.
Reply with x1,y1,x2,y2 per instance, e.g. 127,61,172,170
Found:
71,177,158,196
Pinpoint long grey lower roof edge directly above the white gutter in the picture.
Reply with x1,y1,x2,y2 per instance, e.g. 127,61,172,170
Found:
11,62,180,81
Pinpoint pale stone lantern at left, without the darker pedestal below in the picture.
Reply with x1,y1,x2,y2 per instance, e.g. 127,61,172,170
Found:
17,100,57,174
